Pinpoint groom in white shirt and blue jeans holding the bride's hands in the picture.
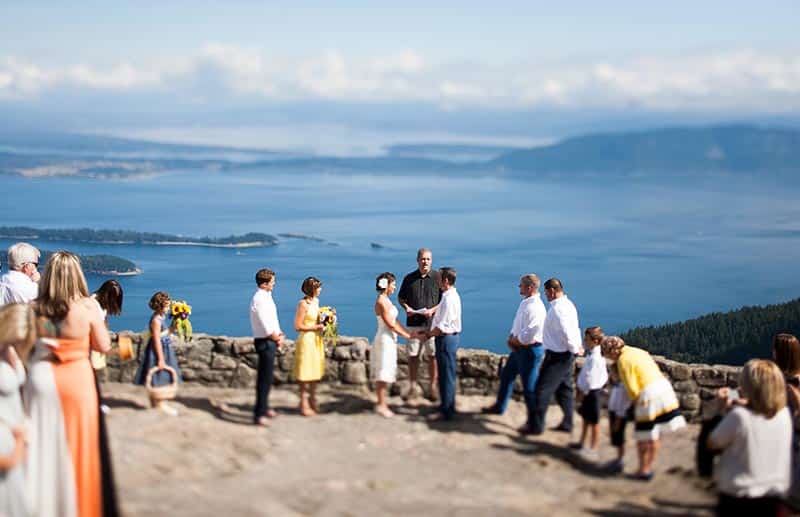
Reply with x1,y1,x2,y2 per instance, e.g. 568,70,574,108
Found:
418,267,461,420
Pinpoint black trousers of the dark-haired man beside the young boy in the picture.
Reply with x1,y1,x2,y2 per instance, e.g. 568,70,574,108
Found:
528,350,575,434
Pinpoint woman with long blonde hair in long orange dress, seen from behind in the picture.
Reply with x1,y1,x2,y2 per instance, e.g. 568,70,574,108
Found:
25,251,118,517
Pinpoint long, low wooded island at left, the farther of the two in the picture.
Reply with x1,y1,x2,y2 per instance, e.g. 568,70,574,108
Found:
0,226,278,248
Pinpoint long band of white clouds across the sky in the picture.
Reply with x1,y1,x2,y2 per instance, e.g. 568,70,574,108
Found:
0,43,800,112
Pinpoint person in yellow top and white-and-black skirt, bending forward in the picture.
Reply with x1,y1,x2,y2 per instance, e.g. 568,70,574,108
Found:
601,336,686,481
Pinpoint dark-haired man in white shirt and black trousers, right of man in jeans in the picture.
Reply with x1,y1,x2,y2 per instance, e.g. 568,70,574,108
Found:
519,278,583,434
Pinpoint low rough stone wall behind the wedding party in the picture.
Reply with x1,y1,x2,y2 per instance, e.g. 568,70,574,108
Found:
102,333,741,421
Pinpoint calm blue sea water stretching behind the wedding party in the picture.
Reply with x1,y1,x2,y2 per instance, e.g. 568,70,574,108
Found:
0,170,800,351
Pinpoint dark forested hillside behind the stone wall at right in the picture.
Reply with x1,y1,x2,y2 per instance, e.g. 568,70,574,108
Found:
620,298,800,364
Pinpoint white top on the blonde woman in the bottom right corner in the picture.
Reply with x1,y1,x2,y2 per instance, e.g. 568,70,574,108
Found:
709,406,792,497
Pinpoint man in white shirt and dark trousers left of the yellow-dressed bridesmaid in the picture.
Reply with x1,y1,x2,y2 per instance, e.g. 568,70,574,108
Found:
250,269,283,426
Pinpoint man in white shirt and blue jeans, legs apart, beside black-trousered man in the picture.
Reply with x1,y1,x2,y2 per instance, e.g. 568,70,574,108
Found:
483,273,546,415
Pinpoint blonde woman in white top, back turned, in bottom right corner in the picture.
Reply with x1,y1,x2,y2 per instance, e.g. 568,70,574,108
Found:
708,359,792,515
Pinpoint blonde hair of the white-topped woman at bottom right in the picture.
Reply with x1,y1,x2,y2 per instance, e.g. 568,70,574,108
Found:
739,359,786,418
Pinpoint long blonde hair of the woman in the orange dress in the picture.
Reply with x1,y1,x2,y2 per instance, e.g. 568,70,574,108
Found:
36,251,89,320
